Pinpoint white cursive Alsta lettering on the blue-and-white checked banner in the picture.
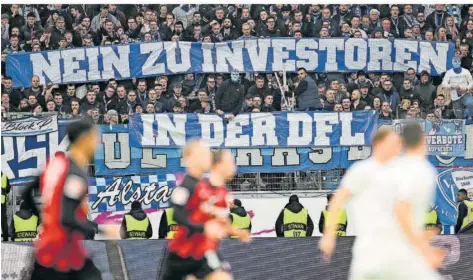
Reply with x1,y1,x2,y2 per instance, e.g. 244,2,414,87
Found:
91,178,172,210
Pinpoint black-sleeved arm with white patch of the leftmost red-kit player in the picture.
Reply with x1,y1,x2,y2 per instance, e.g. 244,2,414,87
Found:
61,175,96,236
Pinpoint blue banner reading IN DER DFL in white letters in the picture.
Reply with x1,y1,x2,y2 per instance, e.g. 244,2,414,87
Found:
129,110,378,148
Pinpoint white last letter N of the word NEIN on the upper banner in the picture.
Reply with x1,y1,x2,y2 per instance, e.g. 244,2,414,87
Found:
100,45,130,80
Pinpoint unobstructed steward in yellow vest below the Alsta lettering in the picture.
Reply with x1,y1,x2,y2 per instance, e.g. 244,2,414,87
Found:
120,201,153,239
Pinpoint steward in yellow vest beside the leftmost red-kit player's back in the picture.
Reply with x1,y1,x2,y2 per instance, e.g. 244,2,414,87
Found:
10,201,40,242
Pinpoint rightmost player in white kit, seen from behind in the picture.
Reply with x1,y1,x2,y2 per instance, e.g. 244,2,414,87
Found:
379,123,445,280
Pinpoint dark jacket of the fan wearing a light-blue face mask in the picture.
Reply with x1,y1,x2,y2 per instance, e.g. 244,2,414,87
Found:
215,80,245,116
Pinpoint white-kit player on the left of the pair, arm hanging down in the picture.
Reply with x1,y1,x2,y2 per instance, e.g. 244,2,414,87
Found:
320,127,401,279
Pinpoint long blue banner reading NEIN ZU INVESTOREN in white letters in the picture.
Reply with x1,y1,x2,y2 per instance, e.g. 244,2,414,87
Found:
6,38,455,87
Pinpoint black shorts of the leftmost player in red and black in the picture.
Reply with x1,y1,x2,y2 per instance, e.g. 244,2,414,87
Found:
31,259,102,280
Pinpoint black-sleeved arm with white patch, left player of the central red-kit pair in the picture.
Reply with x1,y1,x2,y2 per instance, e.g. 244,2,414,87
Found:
171,175,204,232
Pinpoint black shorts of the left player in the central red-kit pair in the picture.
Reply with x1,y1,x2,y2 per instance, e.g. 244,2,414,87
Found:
161,252,230,280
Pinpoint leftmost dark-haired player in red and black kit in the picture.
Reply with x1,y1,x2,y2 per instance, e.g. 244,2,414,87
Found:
23,120,118,280
